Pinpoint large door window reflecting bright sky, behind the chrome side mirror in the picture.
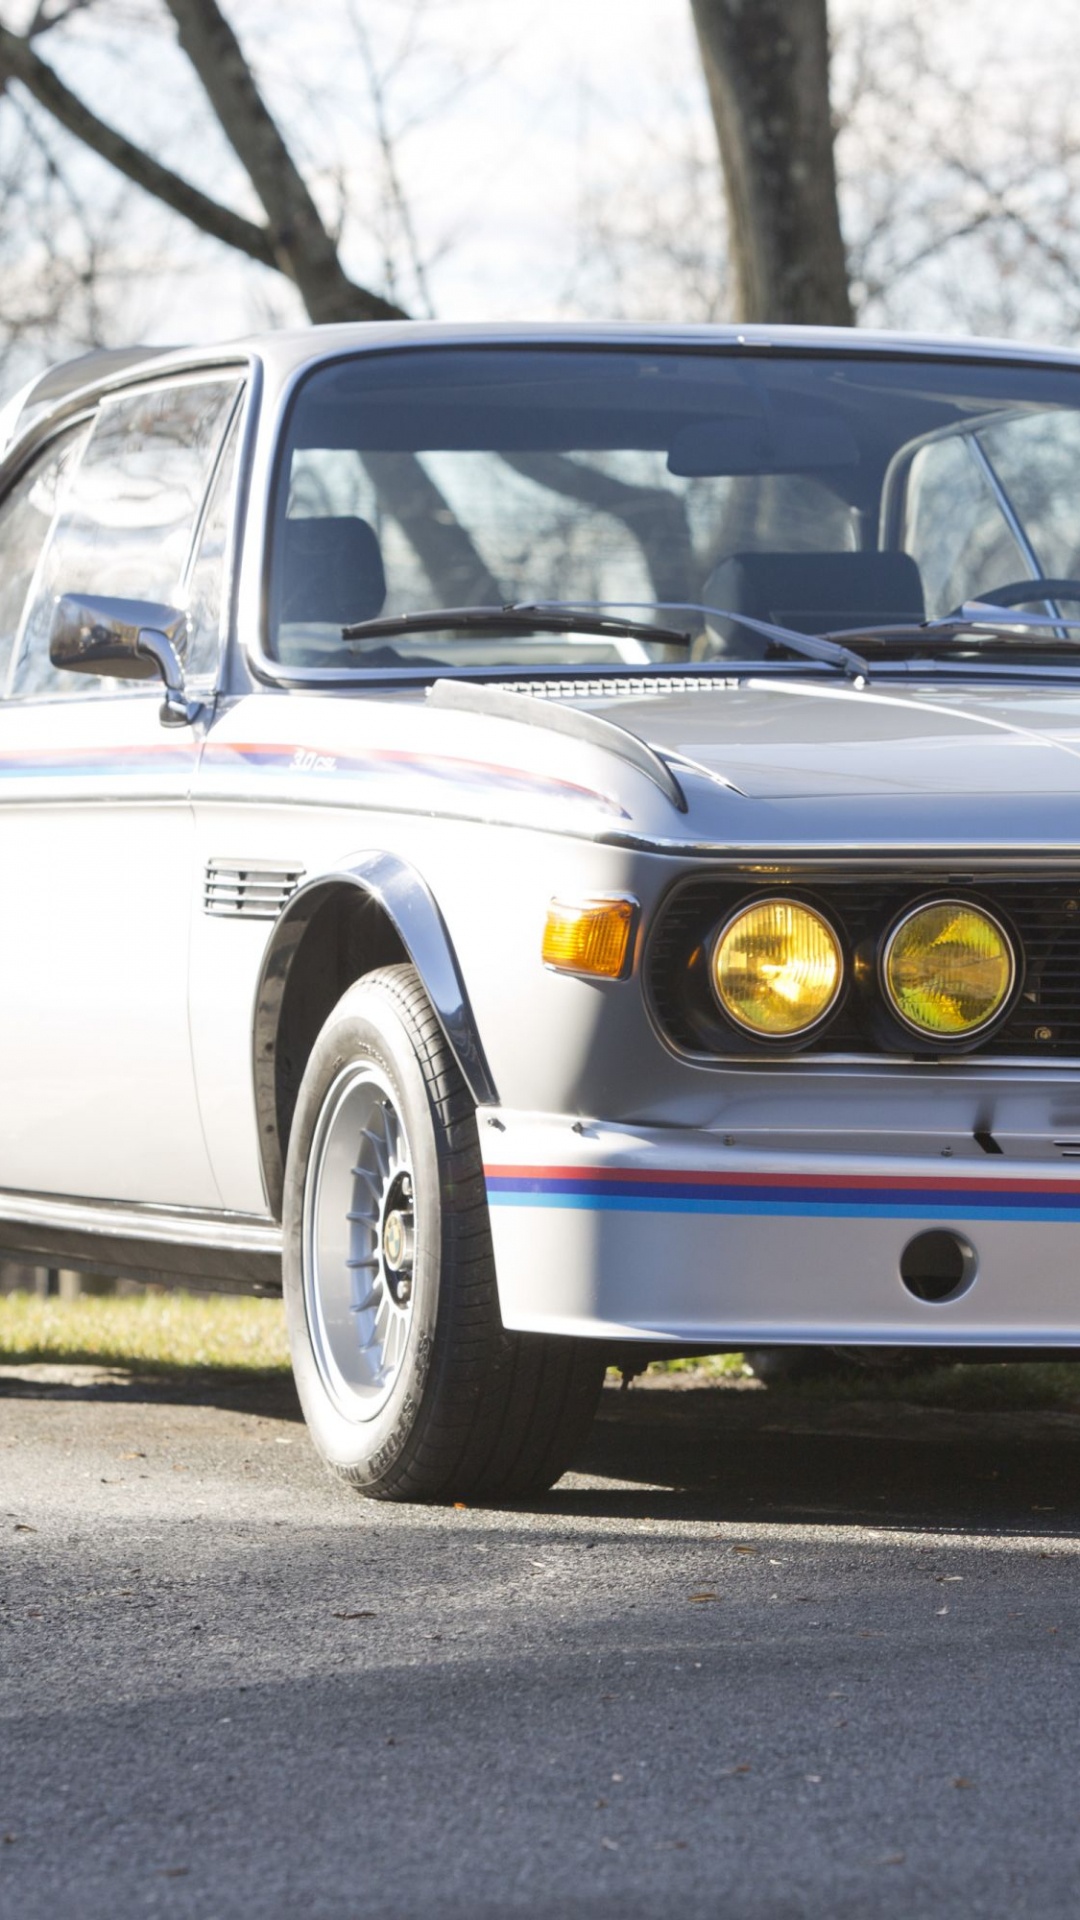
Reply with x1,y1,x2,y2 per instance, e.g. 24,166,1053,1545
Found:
12,380,236,697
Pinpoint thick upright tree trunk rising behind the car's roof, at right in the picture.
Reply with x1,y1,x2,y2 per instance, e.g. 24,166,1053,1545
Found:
690,0,853,326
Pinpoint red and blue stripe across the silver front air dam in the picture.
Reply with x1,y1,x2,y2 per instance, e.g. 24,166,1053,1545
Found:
486,1167,1080,1225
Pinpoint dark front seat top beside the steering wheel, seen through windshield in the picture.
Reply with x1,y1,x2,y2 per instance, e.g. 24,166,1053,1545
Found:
701,553,926,659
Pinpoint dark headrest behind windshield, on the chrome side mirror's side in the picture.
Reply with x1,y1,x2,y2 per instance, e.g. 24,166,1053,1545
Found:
281,515,386,626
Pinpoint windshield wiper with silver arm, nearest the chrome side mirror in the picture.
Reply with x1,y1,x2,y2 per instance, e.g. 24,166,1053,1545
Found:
342,601,871,684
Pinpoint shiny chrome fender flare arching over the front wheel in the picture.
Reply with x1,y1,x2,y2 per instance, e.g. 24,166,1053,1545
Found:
252,852,498,1212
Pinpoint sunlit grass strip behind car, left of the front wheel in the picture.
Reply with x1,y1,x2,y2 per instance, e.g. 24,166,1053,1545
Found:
0,1290,288,1373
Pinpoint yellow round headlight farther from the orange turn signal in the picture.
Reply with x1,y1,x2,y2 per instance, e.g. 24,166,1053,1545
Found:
882,900,1017,1039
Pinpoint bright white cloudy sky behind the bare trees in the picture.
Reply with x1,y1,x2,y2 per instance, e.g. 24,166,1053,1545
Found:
0,0,1080,382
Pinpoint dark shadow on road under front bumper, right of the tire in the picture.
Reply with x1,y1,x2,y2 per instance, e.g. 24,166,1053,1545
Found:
546,1386,1080,1534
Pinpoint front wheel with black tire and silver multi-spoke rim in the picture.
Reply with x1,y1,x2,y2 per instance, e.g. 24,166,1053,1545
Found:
284,966,603,1500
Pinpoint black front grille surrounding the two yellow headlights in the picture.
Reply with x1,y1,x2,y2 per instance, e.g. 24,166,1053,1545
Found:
646,860,1080,1060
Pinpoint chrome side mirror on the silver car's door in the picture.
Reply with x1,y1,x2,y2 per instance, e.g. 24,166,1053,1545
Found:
48,593,200,726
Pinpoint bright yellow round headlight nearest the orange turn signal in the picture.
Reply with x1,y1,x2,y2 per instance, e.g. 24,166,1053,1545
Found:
711,900,844,1039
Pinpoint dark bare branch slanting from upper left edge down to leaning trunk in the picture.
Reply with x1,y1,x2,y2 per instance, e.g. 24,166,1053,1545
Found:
0,27,279,267
